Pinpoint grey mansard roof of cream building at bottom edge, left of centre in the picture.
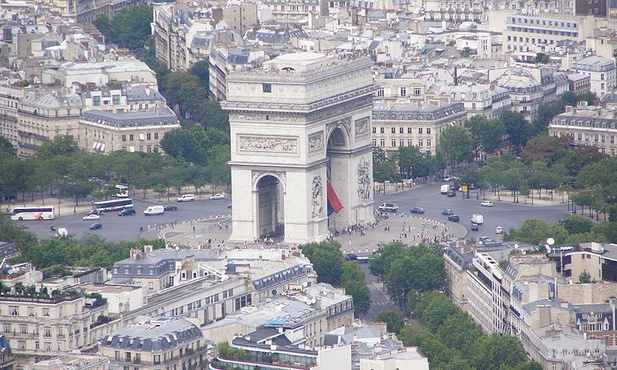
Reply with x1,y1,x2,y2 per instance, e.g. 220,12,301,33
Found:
101,317,203,352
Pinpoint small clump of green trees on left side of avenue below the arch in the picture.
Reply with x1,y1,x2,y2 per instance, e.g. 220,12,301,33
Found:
299,241,371,314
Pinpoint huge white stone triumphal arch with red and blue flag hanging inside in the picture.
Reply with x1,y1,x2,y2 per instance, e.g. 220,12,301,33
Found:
221,53,374,243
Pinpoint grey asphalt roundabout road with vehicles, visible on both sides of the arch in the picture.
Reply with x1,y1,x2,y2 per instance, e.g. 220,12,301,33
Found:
20,182,567,241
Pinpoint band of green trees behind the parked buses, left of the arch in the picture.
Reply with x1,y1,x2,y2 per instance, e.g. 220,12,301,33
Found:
0,136,229,207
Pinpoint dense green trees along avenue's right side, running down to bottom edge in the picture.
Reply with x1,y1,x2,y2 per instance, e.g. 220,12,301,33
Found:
369,242,542,370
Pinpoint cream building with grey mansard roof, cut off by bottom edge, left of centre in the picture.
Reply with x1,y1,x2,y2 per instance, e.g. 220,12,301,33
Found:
99,317,207,370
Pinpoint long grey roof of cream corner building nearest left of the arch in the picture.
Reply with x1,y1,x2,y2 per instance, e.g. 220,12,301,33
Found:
83,108,178,127
